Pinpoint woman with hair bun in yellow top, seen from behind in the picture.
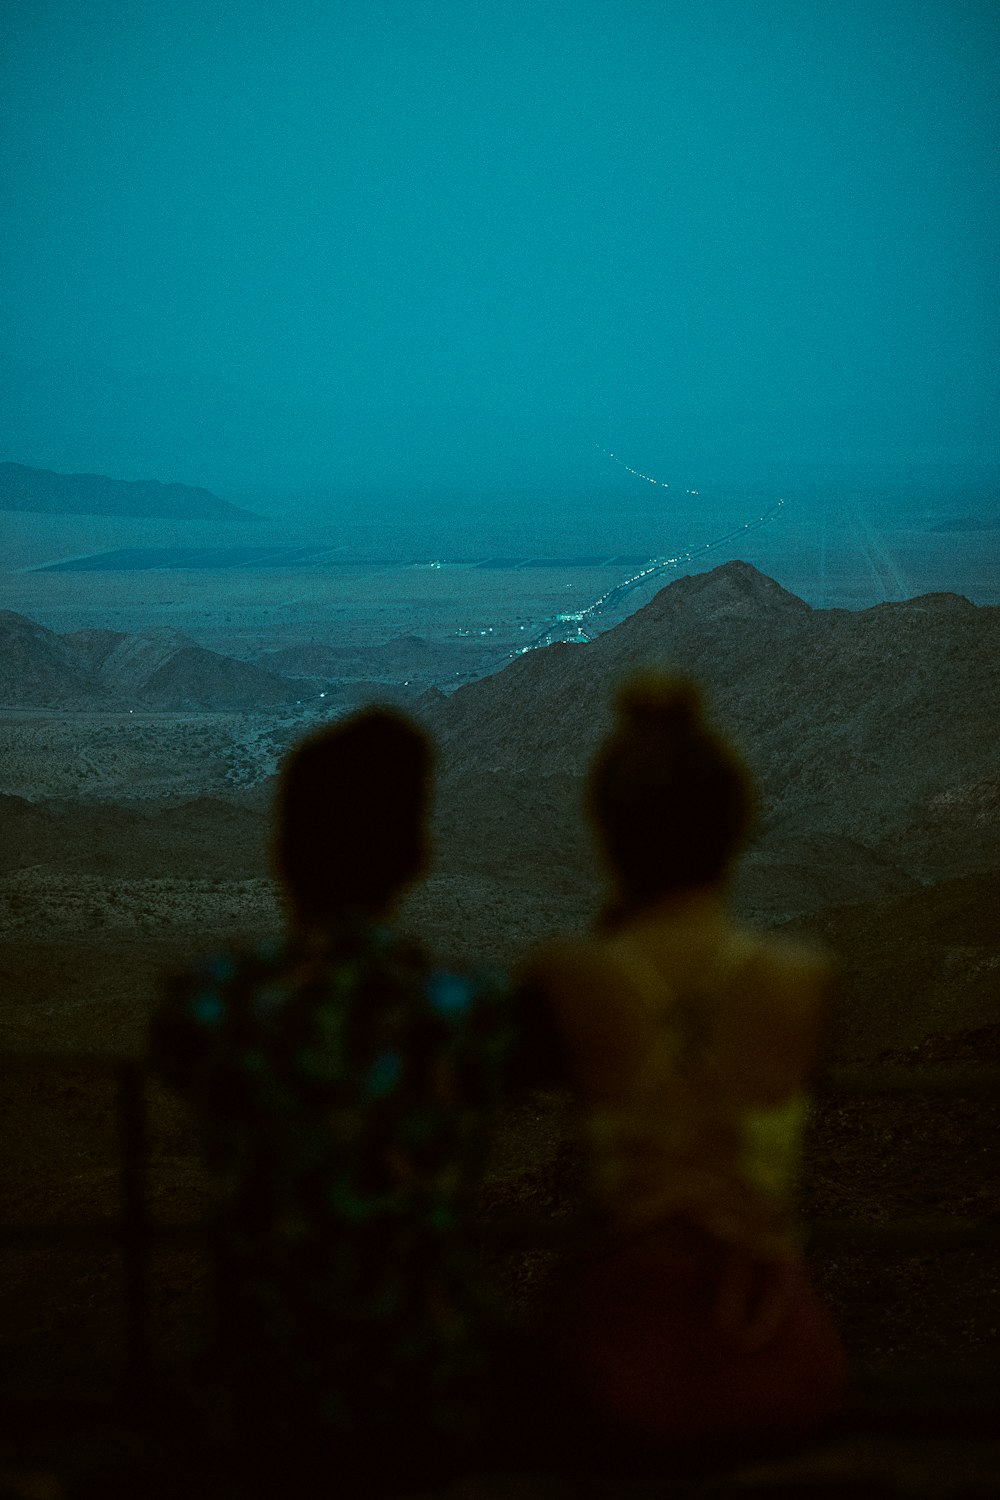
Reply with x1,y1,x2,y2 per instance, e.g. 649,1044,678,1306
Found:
532,674,844,1448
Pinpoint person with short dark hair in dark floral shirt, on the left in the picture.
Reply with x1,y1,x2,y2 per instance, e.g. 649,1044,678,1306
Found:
153,710,560,1493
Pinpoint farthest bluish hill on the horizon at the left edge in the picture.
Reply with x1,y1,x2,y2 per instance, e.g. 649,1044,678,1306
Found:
0,464,252,521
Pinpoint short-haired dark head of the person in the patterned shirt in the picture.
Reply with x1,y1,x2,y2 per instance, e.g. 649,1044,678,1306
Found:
273,708,432,926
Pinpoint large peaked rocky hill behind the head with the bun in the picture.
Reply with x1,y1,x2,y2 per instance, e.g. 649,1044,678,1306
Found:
421,563,1000,942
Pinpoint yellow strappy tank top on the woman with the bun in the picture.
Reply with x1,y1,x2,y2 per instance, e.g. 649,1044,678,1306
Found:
588,938,810,1254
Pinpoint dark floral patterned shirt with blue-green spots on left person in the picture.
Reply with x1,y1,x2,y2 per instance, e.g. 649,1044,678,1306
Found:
151,924,549,1458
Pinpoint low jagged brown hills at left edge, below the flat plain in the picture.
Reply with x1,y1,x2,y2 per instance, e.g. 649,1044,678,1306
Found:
0,611,301,713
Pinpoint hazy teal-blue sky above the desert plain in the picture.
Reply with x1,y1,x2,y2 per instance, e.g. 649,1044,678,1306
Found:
0,0,1000,497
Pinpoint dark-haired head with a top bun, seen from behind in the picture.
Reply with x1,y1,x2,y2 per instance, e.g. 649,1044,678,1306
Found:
588,672,754,903
